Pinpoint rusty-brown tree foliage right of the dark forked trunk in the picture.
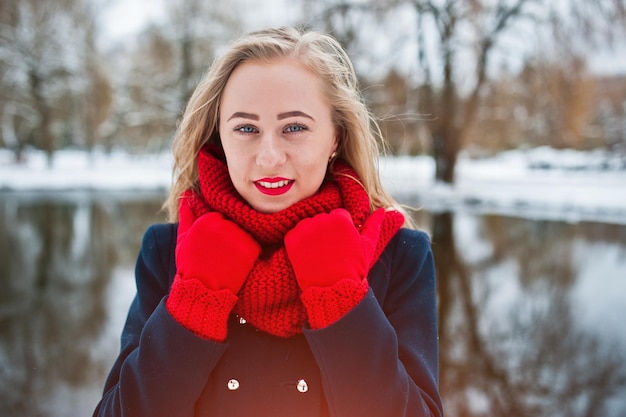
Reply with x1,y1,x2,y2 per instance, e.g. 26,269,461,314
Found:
465,56,596,153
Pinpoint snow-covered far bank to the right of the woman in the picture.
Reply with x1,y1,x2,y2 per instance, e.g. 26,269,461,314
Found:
381,148,626,224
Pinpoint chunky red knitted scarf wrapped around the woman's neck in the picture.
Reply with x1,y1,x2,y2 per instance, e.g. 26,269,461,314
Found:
185,147,404,337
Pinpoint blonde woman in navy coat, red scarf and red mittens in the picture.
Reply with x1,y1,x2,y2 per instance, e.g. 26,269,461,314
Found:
94,28,442,417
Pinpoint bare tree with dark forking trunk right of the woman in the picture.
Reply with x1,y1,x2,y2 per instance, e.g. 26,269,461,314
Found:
412,0,534,182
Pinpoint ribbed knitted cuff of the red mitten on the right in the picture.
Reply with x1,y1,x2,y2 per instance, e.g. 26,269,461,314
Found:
302,279,369,329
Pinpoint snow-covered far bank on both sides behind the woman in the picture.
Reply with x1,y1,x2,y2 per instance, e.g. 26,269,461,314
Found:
0,148,626,224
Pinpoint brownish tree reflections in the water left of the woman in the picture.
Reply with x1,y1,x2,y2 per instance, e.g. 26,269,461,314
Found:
0,190,166,416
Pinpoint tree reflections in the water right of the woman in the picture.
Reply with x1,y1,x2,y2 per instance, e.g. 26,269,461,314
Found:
433,213,626,416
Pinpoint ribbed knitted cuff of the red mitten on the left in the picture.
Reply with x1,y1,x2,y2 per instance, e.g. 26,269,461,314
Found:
165,275,237,342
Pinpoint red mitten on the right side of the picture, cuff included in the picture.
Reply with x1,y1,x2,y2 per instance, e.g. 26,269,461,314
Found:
285,209,385,329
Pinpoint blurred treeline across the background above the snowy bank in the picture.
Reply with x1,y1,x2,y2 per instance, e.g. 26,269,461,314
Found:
0,0,626,182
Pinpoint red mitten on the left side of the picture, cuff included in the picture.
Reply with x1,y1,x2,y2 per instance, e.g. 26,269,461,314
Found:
166,202,261,341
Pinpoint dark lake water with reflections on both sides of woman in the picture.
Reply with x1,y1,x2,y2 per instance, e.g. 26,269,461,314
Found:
0,192,626,417
